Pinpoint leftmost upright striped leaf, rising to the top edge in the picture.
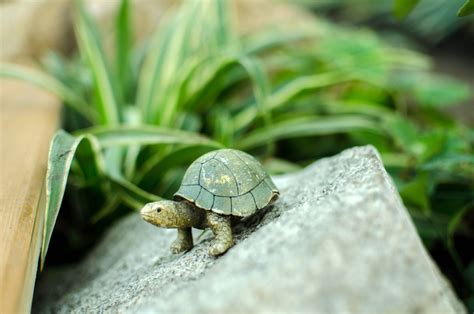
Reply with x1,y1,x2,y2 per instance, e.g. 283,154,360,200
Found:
74,0,120,125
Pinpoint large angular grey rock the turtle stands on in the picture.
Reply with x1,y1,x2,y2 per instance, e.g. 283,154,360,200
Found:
33,146,465,313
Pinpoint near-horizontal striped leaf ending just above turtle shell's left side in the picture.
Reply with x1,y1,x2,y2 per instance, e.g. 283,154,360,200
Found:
76,126,222,148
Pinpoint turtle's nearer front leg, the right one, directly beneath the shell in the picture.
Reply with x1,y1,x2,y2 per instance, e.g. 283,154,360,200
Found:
206,211,234,256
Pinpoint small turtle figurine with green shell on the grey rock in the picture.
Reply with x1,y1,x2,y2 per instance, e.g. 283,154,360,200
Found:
140,149,280,256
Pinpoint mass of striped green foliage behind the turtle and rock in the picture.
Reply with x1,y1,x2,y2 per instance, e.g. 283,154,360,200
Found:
0,0,474,307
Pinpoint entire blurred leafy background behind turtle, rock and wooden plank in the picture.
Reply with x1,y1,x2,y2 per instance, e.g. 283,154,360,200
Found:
0,0,474,311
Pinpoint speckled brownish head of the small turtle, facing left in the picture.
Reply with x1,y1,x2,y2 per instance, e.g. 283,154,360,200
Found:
140,200,195,228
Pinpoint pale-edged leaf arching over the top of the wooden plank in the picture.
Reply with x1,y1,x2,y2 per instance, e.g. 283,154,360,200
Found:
0,63,92,122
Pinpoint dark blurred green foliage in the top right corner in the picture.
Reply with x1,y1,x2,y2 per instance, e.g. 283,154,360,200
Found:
298,0,474,44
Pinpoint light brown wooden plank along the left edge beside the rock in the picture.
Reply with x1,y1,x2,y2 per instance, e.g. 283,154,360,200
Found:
0,79,60,313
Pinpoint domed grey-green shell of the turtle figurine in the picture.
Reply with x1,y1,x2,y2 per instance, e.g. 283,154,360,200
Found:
174,149,279,217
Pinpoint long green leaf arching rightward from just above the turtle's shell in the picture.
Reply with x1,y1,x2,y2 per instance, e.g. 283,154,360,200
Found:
236,116,381,150
